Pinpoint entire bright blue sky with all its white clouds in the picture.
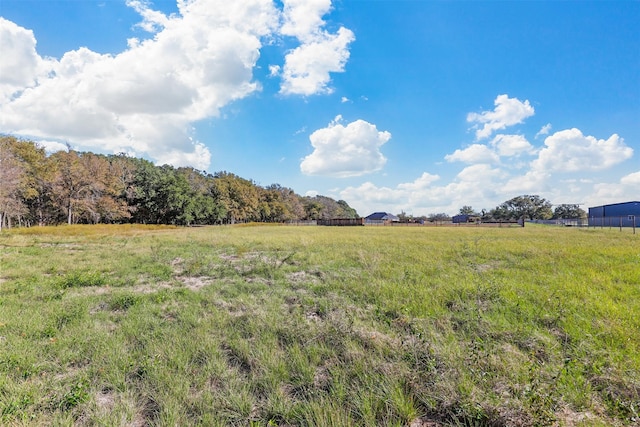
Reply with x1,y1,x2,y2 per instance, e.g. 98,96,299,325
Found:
0,0,640,216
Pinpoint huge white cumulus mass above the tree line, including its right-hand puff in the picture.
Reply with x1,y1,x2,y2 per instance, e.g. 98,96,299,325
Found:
0,0,353,169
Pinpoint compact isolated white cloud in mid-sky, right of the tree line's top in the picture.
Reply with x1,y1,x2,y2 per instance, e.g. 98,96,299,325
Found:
300,116,391,178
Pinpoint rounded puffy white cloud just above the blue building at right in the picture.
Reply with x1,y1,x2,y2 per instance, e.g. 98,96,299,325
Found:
532,128,633,172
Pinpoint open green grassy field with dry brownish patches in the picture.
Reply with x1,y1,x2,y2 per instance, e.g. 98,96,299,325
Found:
0,226,640,427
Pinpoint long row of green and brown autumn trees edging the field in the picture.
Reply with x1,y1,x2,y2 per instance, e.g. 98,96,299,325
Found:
0,136,358,229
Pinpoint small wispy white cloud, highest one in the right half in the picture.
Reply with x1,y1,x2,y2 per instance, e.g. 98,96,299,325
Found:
467,95,535,139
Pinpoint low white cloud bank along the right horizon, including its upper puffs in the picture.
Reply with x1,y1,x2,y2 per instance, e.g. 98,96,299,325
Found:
335,95,640,215
